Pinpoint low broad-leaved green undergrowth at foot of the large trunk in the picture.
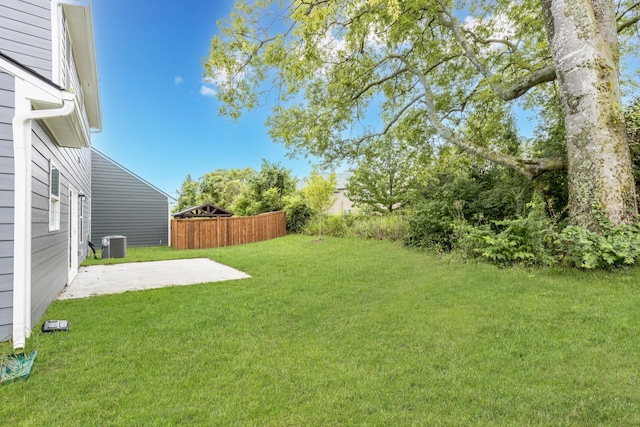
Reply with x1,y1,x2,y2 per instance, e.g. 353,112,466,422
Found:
405,192,640,269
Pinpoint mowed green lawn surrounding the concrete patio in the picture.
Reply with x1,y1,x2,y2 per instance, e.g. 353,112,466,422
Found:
0,236,640,426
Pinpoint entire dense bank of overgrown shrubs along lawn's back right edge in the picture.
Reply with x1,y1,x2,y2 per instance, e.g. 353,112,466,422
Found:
299,151,640,269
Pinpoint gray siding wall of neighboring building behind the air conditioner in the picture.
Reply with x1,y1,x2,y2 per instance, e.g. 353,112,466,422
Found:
91,150,169,246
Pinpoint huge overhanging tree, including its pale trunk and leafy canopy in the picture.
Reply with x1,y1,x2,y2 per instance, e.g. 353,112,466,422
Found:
205,0,640,229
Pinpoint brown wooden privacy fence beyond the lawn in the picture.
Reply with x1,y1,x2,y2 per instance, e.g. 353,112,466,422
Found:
171,211,287,249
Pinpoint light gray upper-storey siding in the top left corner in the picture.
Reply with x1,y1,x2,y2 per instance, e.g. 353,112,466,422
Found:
0,0,52,78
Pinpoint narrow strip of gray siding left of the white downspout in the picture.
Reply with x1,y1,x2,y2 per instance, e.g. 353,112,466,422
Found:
0,72,15,341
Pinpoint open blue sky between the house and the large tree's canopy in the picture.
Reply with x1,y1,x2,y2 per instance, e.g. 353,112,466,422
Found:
92,0,311,197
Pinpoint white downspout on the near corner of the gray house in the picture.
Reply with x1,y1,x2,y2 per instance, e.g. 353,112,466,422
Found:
12,86,75,349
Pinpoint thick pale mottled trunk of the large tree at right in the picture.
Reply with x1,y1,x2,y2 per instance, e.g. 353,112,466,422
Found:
542,0,637,230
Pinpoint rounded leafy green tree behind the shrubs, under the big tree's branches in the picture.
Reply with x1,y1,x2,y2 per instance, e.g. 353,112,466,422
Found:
346,138,426,213
